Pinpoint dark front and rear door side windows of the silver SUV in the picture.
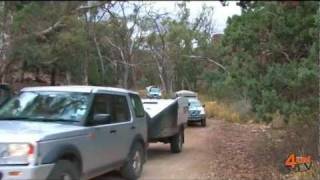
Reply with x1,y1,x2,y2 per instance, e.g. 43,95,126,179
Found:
88,94,130,125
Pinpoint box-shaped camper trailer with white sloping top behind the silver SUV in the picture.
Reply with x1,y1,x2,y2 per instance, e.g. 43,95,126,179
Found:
142,97,188,153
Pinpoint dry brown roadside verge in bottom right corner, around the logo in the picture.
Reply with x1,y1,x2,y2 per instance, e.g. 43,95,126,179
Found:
265,117,320,180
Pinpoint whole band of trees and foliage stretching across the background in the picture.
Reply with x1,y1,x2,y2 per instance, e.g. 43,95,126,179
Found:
0,1,320,124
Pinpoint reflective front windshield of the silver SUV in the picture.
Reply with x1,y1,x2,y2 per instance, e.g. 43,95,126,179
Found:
0,92,89,122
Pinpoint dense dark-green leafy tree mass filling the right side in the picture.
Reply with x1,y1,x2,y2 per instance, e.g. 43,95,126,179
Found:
212,2,319,121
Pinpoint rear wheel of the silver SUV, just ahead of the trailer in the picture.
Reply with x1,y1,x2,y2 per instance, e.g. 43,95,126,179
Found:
120,143,144,180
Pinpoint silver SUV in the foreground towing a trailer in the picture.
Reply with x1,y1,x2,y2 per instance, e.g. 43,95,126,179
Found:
0,86,147,180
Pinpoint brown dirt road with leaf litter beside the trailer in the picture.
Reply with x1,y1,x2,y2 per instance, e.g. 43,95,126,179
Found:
95,119,278,180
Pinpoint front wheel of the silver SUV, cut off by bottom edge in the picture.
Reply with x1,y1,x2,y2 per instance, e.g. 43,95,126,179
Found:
47,160,80,180
